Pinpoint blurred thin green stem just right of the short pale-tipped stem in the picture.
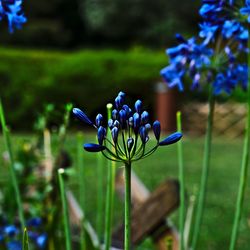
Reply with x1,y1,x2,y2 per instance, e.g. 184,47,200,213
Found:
77,133,86,250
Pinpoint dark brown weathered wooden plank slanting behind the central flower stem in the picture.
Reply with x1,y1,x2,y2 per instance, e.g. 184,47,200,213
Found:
112,180,179,247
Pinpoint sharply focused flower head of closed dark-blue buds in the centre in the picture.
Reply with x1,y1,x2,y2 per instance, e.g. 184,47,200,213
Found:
73,92,182,163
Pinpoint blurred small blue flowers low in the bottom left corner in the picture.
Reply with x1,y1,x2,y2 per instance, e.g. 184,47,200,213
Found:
0,217,48,250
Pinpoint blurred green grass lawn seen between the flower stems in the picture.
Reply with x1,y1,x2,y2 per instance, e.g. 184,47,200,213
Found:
0,134,250,250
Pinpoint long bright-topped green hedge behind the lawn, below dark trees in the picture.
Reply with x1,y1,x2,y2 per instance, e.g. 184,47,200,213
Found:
0,49,166,128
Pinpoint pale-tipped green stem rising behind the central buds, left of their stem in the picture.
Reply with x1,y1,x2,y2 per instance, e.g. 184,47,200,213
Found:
105,103,115,250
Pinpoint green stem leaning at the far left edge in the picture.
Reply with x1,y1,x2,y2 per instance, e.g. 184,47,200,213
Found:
0,100,25,229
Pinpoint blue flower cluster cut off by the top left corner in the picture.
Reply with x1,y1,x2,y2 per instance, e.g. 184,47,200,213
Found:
0,0,27,33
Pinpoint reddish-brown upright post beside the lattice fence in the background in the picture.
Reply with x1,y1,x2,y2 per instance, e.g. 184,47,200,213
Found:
156,82,177,132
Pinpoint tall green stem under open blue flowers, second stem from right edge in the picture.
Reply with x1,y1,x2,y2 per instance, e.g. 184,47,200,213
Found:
192,85,215,250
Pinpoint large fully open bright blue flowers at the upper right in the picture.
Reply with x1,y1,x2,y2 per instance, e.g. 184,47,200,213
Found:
161,0,250,95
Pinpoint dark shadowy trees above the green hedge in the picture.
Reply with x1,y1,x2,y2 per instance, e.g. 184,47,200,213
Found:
0,0,199,49
